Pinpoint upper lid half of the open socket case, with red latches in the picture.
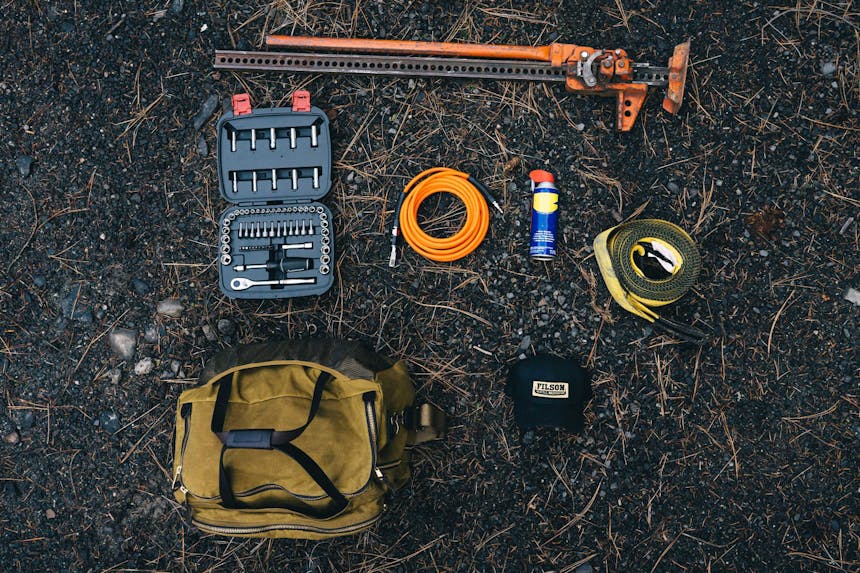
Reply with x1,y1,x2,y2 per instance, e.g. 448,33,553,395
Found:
217,92,331,205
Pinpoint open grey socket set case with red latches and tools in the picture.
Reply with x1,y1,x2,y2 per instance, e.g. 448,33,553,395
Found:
217,94,334,299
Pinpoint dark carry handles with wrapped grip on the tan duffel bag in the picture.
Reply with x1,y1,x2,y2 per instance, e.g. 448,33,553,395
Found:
207,371,349,519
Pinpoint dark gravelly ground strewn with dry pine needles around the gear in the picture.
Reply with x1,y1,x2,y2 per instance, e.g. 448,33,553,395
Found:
0,0,860,572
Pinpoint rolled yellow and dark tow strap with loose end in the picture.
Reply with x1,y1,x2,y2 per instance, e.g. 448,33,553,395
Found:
594,219,706,344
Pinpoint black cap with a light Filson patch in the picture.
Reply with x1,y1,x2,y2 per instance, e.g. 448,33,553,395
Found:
506,354,591,432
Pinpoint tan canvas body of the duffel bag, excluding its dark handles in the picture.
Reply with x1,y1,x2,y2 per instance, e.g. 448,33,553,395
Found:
173,339,415,539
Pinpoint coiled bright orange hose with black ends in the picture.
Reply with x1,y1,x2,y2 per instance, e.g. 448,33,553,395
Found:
388,167,502,267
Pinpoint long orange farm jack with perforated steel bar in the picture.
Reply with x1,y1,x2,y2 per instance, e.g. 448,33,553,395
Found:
215,36,690,131
